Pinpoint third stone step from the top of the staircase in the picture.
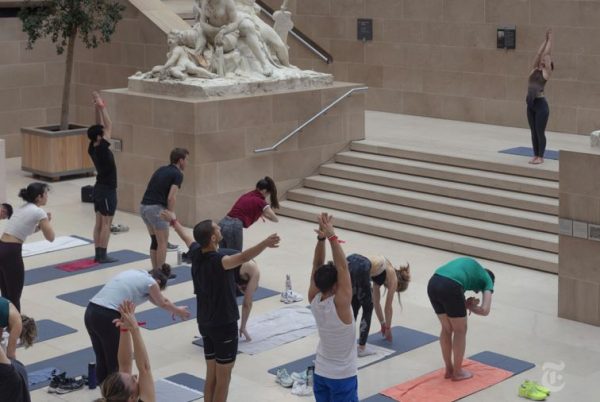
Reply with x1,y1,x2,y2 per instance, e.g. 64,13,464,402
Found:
319,163,558,216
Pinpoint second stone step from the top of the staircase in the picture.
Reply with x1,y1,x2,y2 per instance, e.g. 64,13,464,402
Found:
335,151,558,198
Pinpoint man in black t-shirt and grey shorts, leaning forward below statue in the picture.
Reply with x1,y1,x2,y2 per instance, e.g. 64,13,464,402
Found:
140,148,190,270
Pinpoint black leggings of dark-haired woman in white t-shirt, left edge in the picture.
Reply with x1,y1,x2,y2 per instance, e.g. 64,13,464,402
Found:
0,241,25,312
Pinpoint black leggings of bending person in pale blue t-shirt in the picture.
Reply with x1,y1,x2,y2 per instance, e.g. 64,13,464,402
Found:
84,303,121,384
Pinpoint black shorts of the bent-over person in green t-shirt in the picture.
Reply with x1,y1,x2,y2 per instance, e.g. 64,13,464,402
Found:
427,274,467,318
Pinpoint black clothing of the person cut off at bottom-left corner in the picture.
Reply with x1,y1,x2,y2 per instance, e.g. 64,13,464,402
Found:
0,340,31,402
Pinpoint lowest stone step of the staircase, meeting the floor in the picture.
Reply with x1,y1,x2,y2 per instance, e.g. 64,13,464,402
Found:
279,200,558,273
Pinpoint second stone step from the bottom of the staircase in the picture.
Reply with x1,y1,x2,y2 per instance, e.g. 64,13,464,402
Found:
287,188,558,253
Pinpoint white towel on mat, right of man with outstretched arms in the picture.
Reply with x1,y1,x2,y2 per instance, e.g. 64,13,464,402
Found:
238,306,317,355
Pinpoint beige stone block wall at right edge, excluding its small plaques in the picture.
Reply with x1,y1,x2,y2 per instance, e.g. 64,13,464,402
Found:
558,151,600,326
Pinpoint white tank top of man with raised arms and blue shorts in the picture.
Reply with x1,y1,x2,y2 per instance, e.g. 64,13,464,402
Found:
310,293,358,380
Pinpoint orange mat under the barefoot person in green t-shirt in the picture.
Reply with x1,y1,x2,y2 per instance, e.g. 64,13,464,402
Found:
381,359,513,402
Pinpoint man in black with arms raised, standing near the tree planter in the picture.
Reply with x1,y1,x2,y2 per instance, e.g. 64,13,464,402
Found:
88,91,117,264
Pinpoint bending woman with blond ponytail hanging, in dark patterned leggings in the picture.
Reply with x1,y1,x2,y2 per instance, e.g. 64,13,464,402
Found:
346,254,410,357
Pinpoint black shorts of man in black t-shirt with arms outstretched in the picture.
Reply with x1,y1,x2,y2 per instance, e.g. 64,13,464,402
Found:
198,322,238,364
